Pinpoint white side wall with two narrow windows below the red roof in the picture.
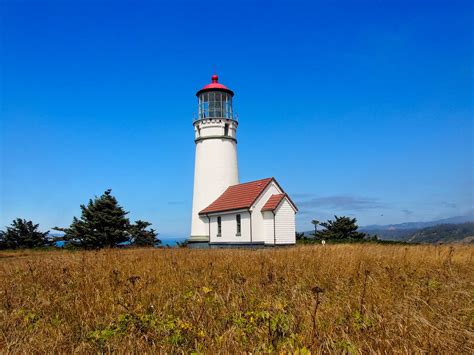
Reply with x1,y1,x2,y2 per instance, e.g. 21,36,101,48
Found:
209,211,253,243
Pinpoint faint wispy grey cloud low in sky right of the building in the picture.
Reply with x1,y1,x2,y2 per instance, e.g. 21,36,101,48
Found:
296,196,385,210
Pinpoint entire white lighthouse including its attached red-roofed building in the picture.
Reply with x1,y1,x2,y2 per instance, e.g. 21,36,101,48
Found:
189,75,298,246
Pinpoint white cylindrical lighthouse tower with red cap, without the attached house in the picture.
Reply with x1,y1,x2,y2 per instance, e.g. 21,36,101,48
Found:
189,75,239,242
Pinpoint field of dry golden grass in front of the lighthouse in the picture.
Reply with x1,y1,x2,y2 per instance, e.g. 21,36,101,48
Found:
0,245,474,353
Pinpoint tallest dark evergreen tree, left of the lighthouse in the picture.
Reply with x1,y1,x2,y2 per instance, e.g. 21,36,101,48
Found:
54,189,130,249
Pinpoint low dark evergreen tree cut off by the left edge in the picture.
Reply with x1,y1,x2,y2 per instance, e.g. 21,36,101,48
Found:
0,218,53,249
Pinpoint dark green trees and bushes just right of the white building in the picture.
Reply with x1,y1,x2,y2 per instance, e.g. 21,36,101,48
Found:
296,216,379,243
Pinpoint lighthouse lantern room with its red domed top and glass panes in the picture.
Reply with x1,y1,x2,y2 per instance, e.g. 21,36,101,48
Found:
196,75,235,120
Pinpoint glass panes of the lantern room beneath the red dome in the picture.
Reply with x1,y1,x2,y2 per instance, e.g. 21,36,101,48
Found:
198,91,233,120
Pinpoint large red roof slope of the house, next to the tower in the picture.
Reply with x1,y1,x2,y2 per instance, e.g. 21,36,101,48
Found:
199,178,274,214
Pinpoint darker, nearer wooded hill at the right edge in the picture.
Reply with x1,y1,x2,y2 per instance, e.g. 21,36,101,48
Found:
406,222,474,244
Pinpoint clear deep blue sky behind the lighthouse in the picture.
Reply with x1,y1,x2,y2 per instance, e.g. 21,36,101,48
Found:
0,0,474,237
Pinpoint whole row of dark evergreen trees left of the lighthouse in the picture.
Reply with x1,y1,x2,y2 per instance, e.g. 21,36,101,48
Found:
0,190,161,249
